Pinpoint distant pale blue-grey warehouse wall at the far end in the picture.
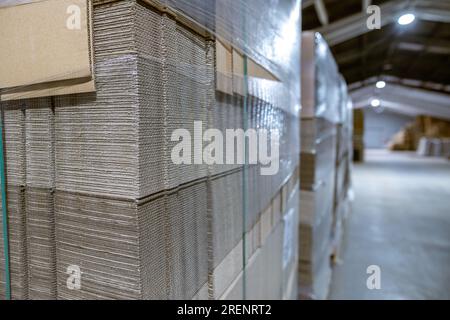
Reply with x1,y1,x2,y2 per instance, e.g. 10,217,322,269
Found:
364,108,414,149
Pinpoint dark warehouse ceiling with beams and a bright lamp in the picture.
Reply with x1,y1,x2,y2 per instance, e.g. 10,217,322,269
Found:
302,0,450,95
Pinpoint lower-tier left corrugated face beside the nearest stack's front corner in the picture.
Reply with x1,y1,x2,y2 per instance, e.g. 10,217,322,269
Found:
55,191,141,299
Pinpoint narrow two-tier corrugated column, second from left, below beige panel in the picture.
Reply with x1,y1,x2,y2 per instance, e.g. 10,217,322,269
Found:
25,98,56,299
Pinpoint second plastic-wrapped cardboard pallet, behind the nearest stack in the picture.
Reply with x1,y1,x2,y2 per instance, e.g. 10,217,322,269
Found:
299,32,340,299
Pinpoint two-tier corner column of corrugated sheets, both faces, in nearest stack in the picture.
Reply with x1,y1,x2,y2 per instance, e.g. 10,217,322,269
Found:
52,1,213,299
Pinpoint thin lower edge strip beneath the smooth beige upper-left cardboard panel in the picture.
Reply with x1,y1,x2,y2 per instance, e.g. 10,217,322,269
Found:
1,80,95,101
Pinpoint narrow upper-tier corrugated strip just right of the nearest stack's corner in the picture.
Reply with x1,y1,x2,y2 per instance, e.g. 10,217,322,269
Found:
135,8,168,197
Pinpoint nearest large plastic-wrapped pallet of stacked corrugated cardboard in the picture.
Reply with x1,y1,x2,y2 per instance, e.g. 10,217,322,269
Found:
0,0,299,299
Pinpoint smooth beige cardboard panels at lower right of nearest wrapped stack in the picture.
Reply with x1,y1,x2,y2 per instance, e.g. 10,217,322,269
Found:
220,171,299,300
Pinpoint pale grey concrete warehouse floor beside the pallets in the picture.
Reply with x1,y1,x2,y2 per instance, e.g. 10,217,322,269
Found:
330,150,450,299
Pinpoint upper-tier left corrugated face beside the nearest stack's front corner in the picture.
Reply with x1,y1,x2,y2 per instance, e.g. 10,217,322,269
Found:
55,1,139,198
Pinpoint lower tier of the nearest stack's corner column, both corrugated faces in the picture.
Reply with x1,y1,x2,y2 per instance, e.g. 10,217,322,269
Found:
56,182,208,299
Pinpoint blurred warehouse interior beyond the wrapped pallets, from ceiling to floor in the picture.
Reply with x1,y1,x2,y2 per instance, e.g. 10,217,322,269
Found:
302,0,450,300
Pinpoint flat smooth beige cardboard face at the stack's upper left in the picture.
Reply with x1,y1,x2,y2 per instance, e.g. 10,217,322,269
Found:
0,0,92,88
